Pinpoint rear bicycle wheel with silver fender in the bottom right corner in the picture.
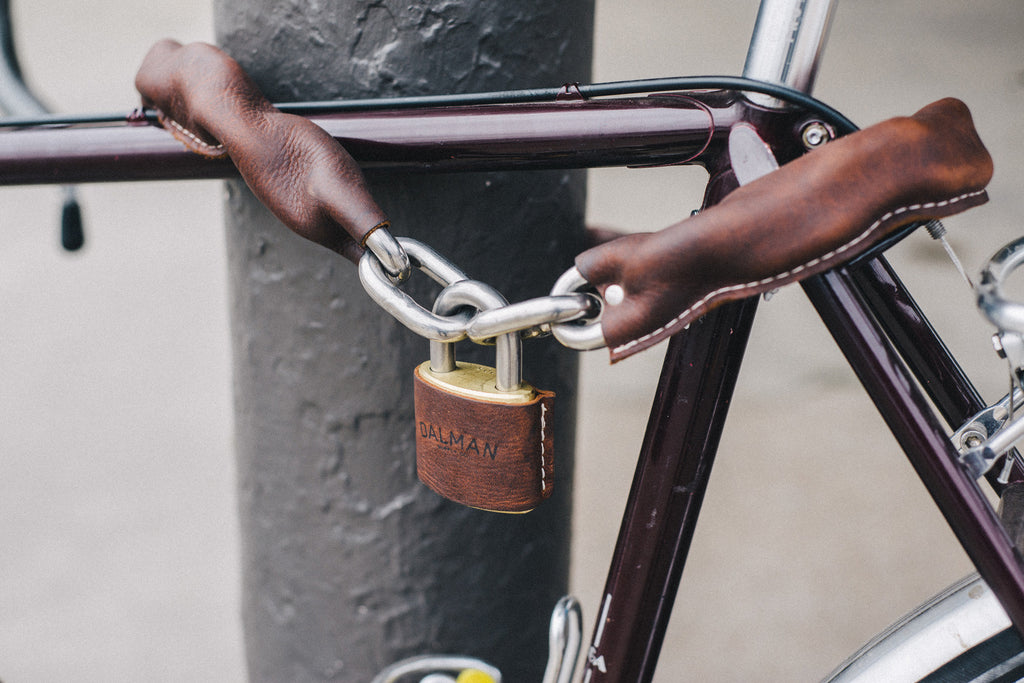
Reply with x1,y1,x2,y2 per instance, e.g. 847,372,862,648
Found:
823,573,1024,683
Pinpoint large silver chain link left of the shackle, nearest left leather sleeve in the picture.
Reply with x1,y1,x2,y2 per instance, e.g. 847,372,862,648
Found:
359,237,470,342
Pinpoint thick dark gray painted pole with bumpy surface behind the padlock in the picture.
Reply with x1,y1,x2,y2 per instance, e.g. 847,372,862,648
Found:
215,0,593,683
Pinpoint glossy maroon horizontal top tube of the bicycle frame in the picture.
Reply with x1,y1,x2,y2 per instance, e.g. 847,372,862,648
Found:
0,92,745,185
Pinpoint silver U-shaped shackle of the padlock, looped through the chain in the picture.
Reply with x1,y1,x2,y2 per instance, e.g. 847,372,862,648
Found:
430,280,522,391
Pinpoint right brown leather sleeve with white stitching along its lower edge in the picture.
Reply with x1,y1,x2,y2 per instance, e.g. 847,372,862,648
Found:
577,99,992,361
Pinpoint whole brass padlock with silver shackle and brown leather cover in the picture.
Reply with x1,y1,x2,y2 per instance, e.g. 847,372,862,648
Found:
414,281,555,512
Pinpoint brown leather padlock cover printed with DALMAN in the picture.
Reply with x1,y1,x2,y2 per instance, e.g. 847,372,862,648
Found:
413,368,555,512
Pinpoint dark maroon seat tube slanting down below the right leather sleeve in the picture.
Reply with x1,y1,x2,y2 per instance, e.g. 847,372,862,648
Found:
583,297,758,683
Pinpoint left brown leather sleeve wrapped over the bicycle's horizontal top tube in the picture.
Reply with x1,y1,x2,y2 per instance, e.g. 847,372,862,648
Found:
135,40,387,261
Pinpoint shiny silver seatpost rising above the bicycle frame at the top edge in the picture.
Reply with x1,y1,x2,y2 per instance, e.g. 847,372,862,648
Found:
743,0,837,100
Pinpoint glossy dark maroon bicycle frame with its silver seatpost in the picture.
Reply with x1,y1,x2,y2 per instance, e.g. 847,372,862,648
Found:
0,0,1024,681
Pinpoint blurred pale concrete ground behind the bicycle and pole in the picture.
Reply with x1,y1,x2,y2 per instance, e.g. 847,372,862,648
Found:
0,0,1024,683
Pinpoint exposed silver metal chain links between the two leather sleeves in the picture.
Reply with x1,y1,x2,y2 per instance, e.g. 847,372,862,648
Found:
359,236,604,350
